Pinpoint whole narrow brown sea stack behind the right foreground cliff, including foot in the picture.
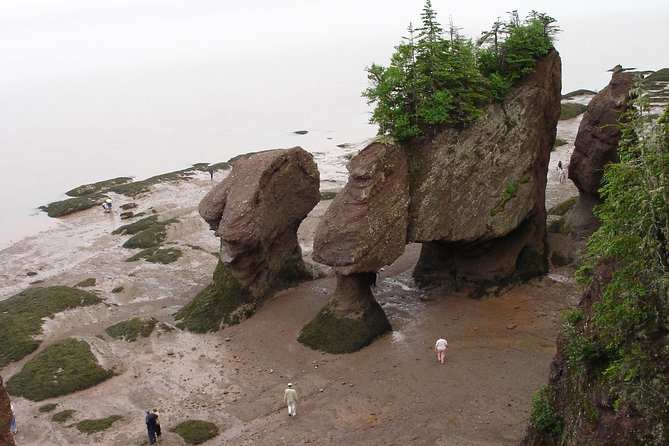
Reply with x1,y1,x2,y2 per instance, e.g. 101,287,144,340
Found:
566,69,634,237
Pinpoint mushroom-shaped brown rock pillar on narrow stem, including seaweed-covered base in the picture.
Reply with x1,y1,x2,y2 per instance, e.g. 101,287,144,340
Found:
300,143,409,353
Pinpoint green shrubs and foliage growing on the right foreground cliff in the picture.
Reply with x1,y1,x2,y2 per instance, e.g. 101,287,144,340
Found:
572,89,669,434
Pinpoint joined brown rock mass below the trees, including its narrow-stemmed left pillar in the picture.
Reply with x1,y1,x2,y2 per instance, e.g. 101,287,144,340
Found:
300,51,561,352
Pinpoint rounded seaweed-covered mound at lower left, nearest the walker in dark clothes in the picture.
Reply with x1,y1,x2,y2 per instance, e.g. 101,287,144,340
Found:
7,339,114,401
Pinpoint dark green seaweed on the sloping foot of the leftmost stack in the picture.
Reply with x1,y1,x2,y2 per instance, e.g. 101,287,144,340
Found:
174,261,254,333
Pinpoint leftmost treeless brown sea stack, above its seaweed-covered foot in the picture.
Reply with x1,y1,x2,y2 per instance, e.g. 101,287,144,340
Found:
176,147,320,331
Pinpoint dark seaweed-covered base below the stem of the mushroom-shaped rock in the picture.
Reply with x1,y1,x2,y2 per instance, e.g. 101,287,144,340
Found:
298,302,391,354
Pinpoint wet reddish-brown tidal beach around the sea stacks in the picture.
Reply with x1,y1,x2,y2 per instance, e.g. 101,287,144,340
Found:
0,106,580,446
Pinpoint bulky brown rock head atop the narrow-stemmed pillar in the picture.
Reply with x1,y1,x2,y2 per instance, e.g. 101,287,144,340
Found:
314,143,409,275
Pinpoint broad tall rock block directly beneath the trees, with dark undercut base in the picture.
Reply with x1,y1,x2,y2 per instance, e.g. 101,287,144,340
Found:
407,51,561,285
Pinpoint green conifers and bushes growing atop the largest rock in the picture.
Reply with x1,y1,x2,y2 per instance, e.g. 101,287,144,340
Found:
363,0,558,140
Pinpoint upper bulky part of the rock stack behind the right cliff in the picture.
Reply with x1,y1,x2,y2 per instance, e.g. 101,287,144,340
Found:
569,71,634,197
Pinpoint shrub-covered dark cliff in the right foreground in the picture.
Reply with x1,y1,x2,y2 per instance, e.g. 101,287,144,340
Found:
548,90,669,445
